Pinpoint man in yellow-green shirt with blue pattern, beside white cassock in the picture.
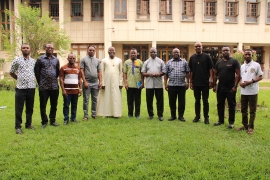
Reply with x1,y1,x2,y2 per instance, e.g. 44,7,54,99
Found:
123,48,144,119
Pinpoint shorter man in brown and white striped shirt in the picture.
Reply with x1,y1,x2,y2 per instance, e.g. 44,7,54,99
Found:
59,54,82,125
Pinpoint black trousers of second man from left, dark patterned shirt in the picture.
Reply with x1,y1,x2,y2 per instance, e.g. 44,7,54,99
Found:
39,89,59,124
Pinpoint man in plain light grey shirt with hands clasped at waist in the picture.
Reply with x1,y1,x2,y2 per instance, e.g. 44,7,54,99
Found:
142,47,165,121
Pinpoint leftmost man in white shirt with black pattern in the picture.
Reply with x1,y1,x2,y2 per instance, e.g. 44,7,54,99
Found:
10,44,36,134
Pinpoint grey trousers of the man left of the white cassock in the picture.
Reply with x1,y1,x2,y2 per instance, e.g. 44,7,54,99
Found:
83,86,99,118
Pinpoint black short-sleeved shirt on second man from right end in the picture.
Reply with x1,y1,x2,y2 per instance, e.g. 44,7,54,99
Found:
215,57,240,91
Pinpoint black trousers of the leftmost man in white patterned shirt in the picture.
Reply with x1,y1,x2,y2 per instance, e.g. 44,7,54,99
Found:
15,89,35,129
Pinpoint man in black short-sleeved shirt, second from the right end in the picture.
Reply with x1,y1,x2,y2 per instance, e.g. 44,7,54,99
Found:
213,46,240,128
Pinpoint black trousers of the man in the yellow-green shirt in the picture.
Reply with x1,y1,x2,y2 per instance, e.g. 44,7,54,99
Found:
127,88,142,116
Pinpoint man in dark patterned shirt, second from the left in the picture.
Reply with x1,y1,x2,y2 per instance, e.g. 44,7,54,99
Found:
35,43,59,128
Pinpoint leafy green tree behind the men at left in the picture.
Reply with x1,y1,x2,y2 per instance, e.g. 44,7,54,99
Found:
2,3,71,59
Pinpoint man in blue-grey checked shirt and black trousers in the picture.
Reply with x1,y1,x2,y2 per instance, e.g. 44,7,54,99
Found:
164,48,190,122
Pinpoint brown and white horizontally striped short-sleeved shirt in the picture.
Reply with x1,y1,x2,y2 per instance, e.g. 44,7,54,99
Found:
59,64,81,94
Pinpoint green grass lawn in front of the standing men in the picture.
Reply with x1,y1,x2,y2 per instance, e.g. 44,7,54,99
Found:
0,90,270,180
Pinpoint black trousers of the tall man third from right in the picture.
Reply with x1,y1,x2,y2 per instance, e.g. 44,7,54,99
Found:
193,86,209,118
